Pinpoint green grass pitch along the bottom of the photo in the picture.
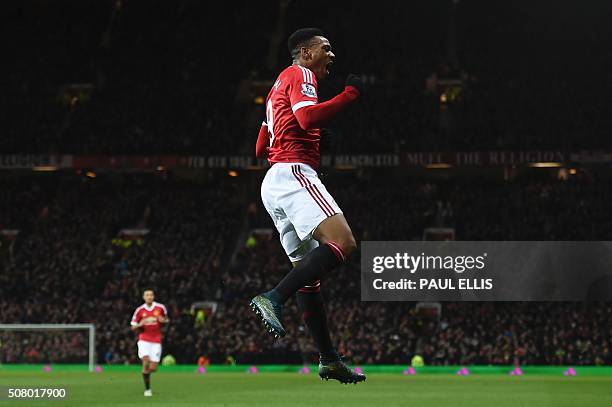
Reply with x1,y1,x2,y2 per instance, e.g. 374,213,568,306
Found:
0,372,612,407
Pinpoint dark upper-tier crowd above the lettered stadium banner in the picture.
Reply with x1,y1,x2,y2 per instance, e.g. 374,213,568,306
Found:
0,0,612,154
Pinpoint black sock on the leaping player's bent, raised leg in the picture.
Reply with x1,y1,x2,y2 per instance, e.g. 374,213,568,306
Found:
267,244,343,304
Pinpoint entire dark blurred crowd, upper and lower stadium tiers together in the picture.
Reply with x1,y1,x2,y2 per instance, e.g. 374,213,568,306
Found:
0,0,612,365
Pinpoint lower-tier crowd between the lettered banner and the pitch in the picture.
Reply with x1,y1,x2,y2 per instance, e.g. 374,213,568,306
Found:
0,171,612,365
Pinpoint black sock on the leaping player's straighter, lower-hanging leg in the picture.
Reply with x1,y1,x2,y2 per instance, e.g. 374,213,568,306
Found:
296,289,336,358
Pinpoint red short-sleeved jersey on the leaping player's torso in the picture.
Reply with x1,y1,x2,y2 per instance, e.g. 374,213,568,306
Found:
266,65,321,168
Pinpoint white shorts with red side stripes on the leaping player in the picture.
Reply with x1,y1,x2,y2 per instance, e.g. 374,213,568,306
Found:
261,163,342,262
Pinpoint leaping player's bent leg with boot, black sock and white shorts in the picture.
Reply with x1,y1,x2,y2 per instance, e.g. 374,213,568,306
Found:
251,164,355,336
